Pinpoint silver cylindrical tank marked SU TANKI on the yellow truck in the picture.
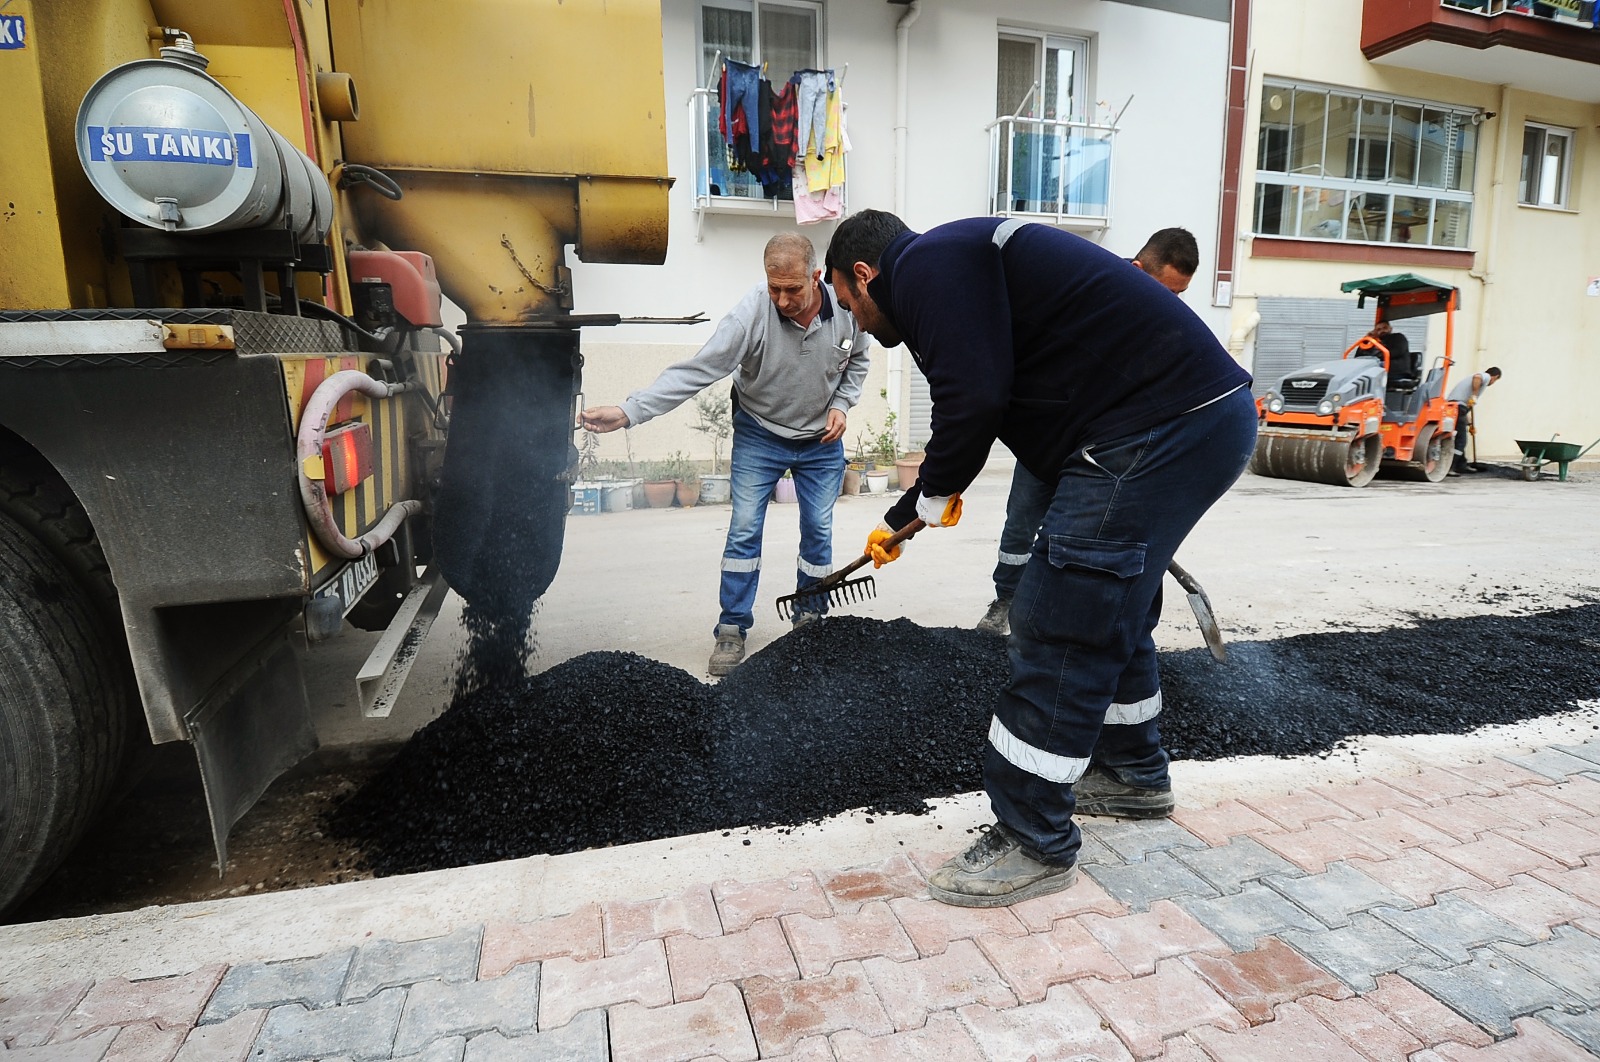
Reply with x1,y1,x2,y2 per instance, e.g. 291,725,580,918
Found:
77,42,333,243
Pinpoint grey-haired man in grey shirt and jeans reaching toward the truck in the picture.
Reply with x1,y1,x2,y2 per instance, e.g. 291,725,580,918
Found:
582,232,870,675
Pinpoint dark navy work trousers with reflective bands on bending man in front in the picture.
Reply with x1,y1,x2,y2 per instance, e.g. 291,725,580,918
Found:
984,389,1256,864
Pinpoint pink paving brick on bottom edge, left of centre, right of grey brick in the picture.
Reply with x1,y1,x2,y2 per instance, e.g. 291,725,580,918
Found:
606,985,760,1062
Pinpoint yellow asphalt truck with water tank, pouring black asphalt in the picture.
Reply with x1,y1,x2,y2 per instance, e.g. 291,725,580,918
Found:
0,0,669,910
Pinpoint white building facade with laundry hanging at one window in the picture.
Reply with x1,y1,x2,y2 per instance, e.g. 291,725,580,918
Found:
571,0,1230,461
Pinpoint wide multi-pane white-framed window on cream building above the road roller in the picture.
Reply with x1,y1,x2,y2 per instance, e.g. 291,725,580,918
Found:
1254,78,1478,248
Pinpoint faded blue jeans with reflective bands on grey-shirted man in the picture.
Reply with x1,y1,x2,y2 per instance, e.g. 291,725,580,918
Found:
717,409,845,633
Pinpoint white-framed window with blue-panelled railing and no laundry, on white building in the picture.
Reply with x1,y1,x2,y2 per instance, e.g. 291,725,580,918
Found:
990,29,1112,219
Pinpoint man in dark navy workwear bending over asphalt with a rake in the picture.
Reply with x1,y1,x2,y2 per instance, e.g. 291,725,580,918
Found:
827,211,1256,907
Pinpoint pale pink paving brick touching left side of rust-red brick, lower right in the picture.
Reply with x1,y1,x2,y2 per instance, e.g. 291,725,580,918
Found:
1069,958,1248,1059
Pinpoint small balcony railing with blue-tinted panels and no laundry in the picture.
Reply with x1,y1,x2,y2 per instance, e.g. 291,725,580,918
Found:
987,115,1117,229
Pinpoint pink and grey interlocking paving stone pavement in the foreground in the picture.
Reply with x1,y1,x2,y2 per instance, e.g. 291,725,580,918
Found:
0,742,1600,1062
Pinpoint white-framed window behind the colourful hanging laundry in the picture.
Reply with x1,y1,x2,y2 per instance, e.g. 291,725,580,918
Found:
693,0,822,203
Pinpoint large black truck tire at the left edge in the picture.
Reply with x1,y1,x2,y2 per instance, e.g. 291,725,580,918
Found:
0,512,126,912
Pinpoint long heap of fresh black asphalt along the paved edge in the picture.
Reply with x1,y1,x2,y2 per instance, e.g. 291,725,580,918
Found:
330,605,1600,875
